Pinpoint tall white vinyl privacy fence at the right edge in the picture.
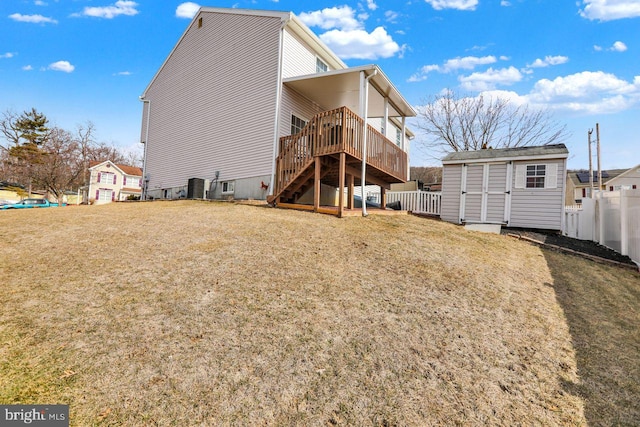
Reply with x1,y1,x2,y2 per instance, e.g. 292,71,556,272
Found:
563,190,640,265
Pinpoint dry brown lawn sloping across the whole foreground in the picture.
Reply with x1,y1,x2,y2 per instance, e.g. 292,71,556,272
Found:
0,201,640,426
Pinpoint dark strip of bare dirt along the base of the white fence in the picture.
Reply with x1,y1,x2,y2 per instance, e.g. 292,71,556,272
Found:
502,228,636,266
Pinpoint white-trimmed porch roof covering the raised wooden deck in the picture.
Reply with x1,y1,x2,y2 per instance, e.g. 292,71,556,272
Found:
282,64,416,117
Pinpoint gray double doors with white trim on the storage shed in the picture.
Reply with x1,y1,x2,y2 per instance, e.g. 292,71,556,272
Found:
460,163,512,224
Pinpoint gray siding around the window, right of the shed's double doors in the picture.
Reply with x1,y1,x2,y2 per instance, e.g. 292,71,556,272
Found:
509,159,566,230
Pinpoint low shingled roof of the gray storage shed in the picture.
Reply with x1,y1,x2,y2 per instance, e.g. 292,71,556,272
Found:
442,144,569,164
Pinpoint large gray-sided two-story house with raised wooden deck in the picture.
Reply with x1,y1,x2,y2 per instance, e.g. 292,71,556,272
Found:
140,7,416,216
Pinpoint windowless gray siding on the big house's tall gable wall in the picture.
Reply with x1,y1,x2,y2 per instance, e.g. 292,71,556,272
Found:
143,12,281,190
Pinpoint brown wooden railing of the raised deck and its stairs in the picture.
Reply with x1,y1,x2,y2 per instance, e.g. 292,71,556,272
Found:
274,107,407,201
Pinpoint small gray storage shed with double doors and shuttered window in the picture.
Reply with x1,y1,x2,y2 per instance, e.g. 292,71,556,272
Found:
440,144,569,230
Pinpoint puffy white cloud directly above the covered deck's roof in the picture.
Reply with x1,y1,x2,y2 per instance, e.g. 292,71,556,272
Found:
320,27,403,59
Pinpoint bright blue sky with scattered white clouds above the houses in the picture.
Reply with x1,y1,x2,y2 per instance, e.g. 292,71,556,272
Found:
0,0,640,168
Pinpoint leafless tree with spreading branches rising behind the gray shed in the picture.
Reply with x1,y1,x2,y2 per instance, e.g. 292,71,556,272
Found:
418,90,568,155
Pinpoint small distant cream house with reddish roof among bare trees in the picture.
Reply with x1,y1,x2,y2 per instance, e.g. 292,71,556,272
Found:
88,160,142,204
